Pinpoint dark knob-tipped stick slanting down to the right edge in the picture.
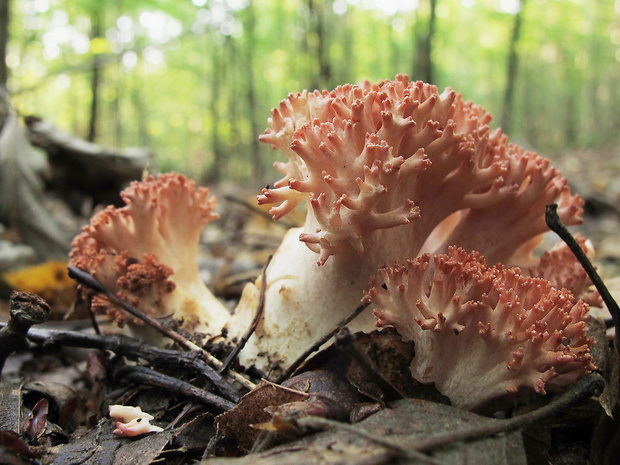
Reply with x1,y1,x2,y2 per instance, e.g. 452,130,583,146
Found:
545,203,620,350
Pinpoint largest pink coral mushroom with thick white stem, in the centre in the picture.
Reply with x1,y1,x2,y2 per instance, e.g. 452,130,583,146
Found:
228,75,583,376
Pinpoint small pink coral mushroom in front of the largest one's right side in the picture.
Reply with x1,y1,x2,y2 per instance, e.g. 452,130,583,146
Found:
365,247,595,409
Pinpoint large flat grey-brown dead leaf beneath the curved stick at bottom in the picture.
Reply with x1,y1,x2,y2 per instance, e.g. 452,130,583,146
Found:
201,399,527,465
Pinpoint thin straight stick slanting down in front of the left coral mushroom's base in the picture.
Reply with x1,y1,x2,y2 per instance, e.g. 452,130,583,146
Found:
68,266,256,390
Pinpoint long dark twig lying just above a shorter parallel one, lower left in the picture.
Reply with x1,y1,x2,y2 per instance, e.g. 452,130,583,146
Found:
23,329,240,402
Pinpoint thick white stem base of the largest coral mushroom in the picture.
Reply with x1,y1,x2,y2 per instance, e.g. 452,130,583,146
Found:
228,228,375,379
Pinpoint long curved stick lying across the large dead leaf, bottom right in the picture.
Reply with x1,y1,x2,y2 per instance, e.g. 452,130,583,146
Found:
297,373,605,458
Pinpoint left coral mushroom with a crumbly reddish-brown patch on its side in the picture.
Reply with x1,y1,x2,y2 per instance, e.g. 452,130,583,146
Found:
69,173,230,334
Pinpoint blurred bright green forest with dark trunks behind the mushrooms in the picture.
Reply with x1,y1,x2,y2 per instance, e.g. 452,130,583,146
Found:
0,0,620,184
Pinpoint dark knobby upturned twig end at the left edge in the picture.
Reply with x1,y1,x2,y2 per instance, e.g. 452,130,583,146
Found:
0,291,50,375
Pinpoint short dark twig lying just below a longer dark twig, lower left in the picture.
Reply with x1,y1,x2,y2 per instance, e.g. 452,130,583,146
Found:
117,366,236,412
